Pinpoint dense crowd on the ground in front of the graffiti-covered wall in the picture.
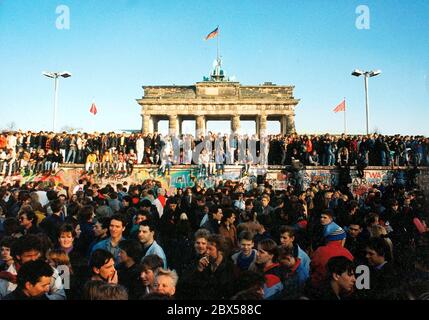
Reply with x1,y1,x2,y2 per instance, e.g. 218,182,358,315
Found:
0,165,429,300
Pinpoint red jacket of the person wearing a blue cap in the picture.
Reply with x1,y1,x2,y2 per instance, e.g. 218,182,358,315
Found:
310,241,354,287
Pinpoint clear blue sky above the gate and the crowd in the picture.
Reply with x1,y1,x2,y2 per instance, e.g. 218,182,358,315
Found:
0,0,429,135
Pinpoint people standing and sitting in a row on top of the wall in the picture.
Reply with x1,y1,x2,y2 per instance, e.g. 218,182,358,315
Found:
0,131,429,176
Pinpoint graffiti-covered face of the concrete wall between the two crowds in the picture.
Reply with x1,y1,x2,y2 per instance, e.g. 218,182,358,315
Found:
1,167,429,195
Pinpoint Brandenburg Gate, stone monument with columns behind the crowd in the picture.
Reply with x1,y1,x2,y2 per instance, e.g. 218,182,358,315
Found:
137,63,299,137
